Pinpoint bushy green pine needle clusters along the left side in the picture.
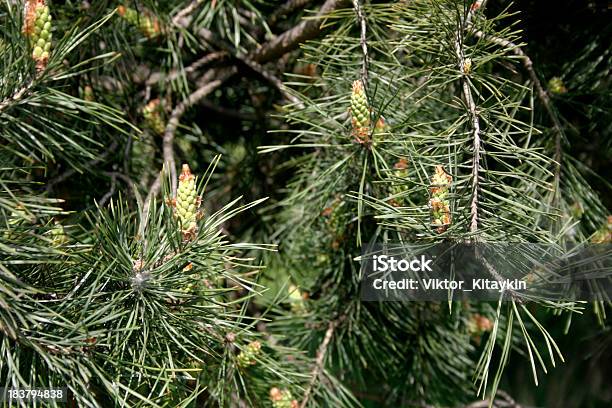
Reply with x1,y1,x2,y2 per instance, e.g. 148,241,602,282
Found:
0,1,334,406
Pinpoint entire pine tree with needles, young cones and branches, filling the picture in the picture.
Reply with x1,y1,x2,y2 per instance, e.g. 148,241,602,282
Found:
0,0,611,408
